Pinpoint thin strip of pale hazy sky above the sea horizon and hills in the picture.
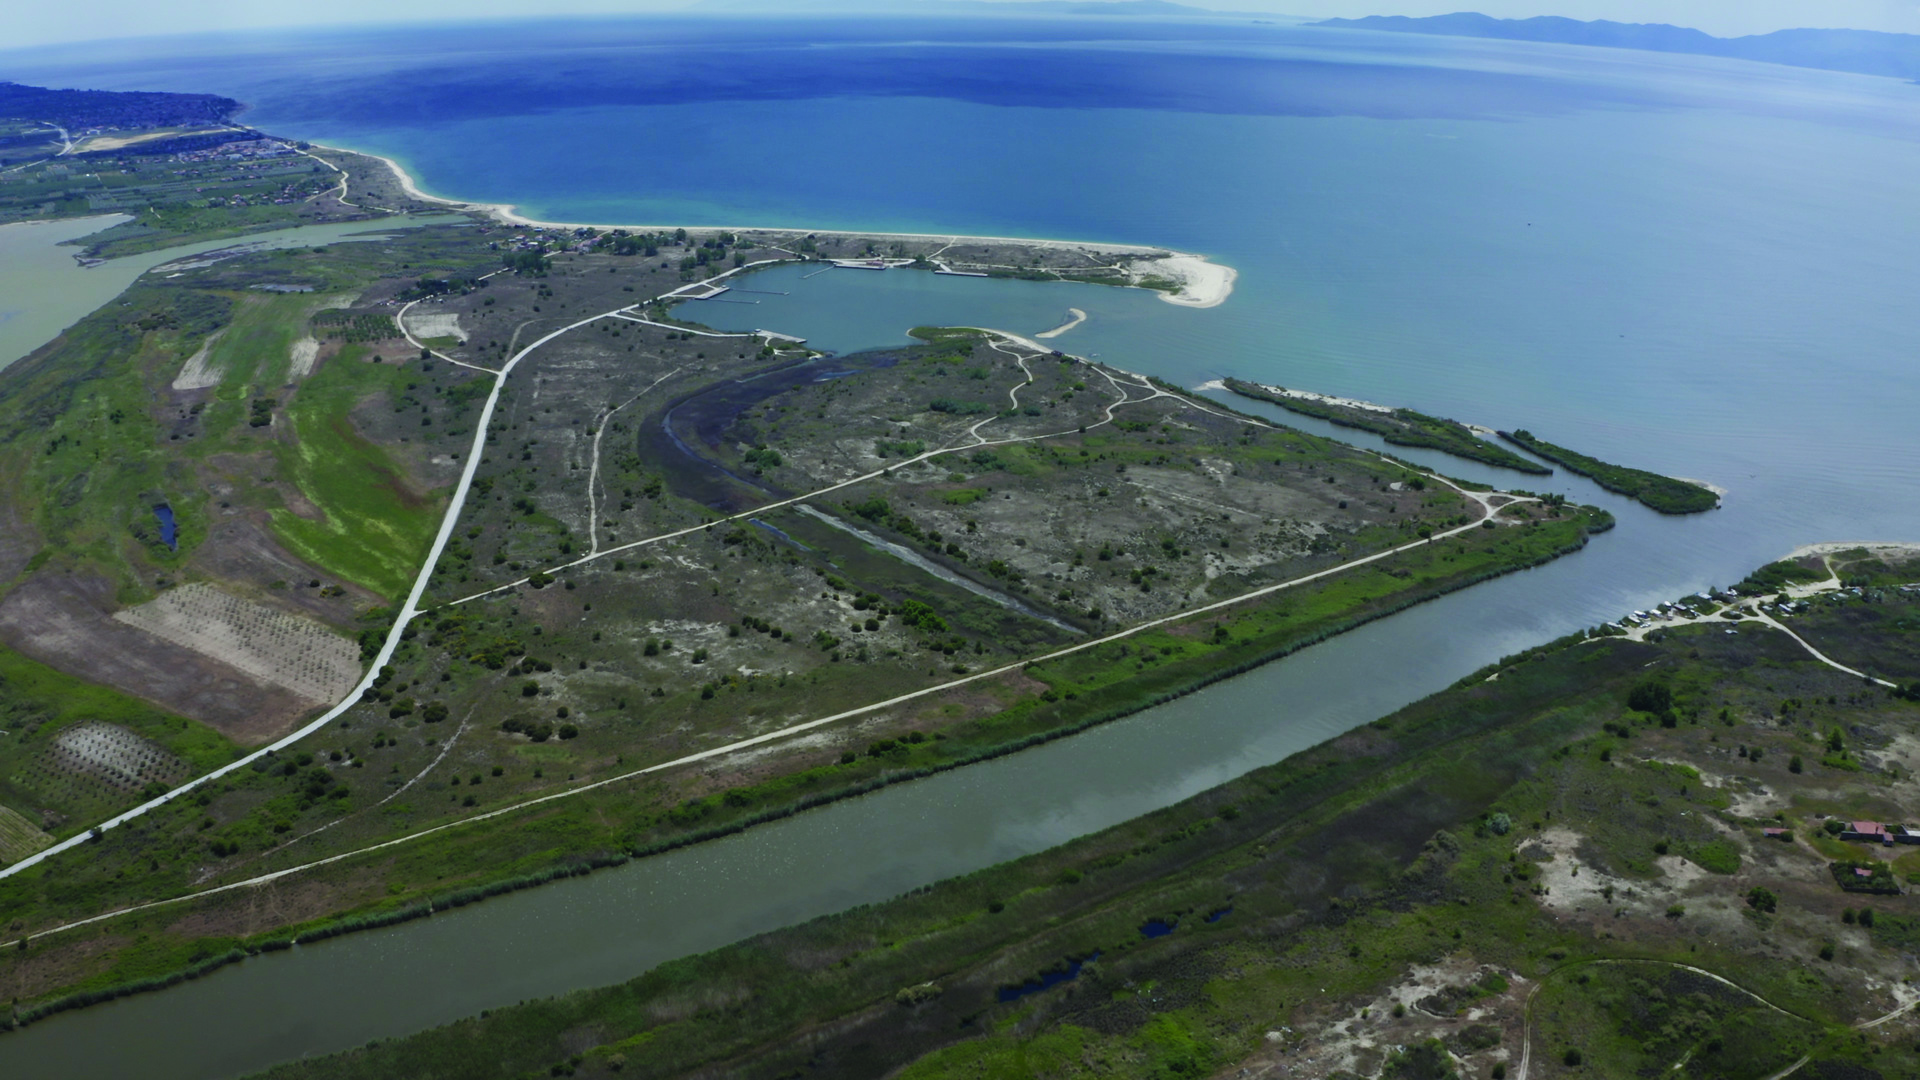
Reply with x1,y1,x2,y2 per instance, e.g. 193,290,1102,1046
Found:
0,0,1920,48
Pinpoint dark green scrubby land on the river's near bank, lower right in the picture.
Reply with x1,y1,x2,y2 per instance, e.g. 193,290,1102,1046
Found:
247,564,1920,1080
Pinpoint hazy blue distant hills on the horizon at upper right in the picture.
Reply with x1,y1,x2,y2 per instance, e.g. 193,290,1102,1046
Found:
1309,12,1920,79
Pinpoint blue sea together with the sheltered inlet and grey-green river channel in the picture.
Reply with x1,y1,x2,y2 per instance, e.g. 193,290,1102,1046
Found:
0,19,1920,1076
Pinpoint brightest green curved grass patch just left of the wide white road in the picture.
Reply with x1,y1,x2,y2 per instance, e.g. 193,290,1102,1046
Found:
273,346,445,600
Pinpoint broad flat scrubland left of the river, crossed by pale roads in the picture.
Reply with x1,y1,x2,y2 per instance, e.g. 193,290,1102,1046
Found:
0,77,1611,1022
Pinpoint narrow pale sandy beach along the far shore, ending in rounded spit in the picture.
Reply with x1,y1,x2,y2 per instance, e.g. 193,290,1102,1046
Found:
332,142,1240,307
